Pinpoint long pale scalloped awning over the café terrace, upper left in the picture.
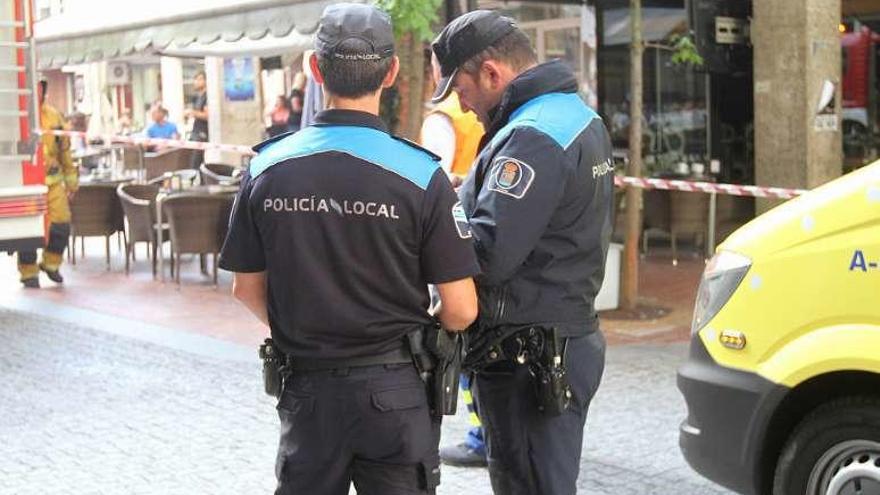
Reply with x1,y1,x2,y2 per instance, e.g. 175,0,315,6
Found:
34,0,340,68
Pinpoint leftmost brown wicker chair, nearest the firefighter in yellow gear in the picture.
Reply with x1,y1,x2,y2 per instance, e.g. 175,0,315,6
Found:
70,183,127,270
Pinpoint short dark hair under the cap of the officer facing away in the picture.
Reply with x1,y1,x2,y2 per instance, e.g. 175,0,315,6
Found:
317,40,392,98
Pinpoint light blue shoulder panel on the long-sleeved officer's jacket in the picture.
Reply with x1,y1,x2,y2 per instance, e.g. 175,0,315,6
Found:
492,93,600,149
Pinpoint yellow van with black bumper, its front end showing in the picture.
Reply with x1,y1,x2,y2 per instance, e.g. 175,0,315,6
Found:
678,161,880,495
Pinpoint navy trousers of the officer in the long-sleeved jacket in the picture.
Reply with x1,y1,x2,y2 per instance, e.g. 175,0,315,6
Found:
474,331,605,495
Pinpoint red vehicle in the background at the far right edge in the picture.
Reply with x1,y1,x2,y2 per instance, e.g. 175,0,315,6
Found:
840,26,880,158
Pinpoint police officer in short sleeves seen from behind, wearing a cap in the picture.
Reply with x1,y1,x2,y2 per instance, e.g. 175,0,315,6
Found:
220,4,479,495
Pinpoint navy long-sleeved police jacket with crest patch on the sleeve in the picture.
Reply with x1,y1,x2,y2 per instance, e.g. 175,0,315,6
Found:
459,61,614,336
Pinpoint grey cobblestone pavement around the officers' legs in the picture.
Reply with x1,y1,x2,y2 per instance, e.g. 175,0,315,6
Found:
0,307,728,495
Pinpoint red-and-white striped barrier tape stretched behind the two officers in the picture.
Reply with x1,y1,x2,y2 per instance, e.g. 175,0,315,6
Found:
39,131,807,199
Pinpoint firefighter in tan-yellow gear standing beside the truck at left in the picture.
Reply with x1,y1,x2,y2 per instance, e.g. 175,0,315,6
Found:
18,81,79,289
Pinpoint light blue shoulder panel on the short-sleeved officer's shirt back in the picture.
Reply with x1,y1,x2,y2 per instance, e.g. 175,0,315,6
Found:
250,126,439,189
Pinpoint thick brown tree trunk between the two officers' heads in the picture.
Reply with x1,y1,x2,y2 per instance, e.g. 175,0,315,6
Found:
397,34,425,141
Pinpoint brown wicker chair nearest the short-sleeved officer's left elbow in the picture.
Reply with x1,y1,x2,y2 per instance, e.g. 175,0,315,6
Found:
162,192,233,287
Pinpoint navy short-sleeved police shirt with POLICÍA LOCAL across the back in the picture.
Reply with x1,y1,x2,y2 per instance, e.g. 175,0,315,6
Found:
220,110,479,359
